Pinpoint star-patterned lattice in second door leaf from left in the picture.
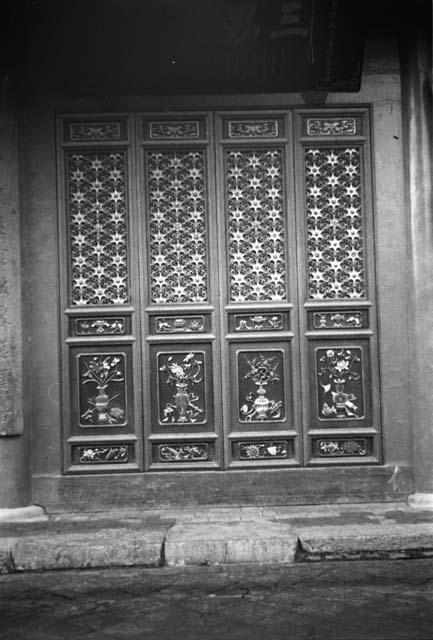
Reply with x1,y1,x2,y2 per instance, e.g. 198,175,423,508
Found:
147,151,208,304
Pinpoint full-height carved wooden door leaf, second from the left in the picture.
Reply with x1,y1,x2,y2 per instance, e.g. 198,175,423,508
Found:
139,114,222,469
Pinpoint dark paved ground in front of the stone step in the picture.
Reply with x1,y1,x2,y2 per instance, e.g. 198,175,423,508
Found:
0,559,433,640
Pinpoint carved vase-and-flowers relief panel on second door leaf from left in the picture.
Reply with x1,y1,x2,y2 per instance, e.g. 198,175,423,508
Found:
158,352,206,424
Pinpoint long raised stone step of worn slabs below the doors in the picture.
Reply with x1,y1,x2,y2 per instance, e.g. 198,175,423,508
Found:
0,502,433,573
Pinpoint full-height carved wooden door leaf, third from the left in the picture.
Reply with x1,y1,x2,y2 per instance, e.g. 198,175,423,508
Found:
216,113,302,468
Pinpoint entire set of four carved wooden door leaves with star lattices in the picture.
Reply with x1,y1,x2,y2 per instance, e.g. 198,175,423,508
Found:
59,108,380,473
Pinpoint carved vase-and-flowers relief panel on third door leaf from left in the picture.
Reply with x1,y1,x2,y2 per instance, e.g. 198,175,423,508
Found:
238,351,284,422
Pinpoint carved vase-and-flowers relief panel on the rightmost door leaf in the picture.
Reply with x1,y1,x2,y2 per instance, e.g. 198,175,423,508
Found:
317,348,364,420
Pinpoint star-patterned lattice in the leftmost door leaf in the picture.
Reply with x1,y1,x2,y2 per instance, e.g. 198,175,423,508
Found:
67,152,129,305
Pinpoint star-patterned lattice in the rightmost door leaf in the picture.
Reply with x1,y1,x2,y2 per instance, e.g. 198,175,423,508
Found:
305,147,366,300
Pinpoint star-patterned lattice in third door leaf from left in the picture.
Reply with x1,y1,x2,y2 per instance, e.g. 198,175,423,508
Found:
226,149,286,302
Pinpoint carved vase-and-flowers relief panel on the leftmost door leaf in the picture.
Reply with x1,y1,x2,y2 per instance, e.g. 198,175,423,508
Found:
78,354,126,426
